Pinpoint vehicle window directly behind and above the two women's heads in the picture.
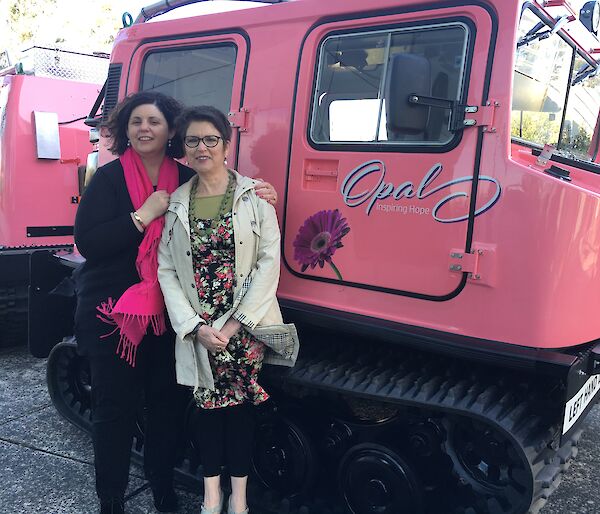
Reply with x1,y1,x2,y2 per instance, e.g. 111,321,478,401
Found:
141,44,236,112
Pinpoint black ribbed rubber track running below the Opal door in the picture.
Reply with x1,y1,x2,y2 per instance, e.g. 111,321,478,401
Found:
261,344,581,514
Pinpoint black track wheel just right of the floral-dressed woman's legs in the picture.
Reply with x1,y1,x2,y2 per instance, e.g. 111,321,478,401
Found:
252,418,317,497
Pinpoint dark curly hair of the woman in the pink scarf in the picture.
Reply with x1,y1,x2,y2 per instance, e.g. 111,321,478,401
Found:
103,91,184,159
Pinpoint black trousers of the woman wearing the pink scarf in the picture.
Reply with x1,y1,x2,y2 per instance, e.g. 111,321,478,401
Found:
88,331,184,501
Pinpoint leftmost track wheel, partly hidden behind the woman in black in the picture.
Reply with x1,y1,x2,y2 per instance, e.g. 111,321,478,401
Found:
46,338,92,432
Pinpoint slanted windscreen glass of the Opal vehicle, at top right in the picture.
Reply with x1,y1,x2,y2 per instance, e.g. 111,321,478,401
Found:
511,9,600,161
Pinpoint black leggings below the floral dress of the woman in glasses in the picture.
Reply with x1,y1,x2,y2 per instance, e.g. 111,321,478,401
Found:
197,403,256,477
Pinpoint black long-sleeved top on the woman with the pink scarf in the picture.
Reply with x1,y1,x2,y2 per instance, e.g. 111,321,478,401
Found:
75,159,194,354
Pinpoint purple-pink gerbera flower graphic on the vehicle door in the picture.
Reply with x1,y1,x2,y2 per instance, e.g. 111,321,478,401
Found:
294,209,350,280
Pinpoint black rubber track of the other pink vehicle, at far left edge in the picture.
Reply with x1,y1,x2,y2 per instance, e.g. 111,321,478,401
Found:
0,285,27,348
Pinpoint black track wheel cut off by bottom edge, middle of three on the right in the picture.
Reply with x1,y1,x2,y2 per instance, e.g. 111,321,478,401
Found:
338,443,423,514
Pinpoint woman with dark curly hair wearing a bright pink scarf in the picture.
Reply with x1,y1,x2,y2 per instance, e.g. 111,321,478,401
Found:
75,92,274,514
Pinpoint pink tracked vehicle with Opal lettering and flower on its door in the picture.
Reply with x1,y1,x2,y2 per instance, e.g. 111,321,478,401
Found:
32,0,600,514
